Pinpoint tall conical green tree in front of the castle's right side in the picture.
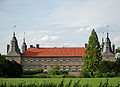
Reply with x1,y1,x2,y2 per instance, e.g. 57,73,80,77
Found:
83,29,102,75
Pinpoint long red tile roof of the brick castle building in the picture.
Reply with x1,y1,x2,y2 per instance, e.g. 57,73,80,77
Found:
22,47,85,57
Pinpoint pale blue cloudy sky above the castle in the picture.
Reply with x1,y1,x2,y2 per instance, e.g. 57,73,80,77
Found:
0,0,120,54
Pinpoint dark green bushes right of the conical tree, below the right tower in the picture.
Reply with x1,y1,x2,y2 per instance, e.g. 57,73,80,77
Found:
93,60,120,77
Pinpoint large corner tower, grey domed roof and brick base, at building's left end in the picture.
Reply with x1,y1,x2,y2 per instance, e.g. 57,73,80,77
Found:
6,32,21,64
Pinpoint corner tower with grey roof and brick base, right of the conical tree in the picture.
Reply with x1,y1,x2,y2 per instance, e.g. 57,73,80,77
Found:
102,33,115,61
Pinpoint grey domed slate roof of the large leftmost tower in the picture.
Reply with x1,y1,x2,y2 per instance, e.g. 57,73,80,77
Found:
7,32,21,56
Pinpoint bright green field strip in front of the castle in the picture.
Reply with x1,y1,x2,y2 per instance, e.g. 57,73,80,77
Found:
0,78,120,87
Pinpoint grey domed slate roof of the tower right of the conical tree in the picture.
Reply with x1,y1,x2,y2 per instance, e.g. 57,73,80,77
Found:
102,33,114,55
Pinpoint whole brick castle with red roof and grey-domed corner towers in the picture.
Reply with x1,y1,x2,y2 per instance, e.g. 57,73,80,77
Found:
6,33,115,75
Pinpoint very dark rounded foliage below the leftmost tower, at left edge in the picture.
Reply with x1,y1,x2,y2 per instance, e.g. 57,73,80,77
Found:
0,56,23,77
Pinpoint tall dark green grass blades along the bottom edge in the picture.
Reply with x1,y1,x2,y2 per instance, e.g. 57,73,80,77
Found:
0,79,120,87
